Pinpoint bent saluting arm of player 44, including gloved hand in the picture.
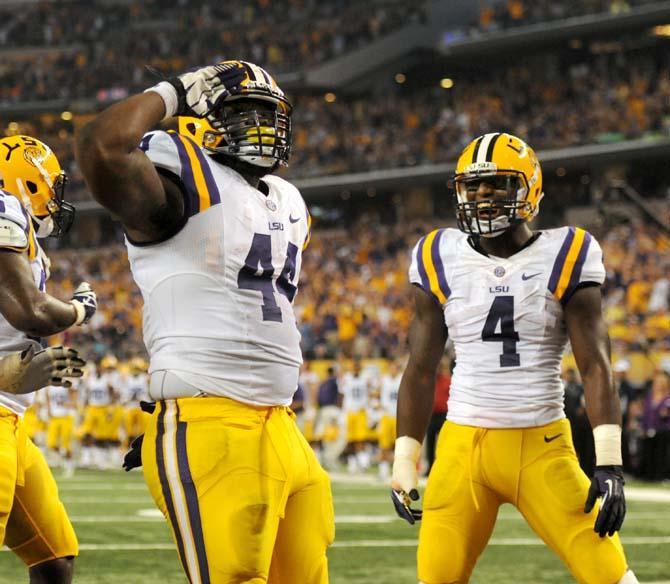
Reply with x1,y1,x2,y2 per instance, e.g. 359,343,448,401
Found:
75,63,245,242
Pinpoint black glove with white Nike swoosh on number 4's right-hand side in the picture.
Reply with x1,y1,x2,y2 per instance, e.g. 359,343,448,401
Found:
584,466,626,537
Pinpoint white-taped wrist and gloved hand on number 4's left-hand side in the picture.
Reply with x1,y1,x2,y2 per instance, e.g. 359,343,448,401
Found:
391,436,422,525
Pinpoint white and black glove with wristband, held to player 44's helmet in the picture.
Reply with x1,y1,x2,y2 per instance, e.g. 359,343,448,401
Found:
146,61,247,118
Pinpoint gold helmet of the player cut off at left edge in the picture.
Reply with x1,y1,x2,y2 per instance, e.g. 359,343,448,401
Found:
0,135,75,237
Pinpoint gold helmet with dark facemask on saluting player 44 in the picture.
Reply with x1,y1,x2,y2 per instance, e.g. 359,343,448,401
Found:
179,61,293,169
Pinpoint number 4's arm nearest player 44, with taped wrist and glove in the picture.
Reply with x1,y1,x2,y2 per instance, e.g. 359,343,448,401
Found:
391,287,447,523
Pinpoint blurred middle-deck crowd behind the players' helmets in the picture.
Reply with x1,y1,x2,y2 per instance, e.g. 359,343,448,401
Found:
5,45,670,200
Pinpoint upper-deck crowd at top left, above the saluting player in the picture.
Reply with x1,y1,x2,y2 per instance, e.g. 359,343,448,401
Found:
0,0,425,103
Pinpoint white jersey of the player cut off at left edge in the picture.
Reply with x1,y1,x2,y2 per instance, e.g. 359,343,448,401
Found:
0,190,49,415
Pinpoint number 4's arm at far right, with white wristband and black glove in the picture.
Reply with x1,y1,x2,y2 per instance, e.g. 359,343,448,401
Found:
564,286,626,537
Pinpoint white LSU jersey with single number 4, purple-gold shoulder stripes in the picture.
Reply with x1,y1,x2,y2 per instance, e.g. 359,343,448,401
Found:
409,227,605,428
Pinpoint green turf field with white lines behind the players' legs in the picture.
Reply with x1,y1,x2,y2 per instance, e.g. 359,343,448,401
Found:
0,471,670,584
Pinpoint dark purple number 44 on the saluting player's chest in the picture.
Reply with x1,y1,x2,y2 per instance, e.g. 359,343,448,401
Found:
237,233,298,322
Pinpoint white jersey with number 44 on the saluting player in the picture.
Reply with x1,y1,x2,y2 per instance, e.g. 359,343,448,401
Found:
126,132,309,405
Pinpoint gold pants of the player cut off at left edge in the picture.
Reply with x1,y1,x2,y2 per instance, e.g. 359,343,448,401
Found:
0,407,79,566
